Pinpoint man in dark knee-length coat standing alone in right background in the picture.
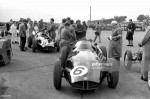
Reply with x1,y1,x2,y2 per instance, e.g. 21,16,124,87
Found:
126,19,136,46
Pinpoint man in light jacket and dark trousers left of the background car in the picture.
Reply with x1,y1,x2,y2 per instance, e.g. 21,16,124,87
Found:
19,20,26,51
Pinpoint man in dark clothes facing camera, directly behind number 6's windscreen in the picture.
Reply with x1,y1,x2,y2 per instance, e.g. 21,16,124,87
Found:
75,20,86,40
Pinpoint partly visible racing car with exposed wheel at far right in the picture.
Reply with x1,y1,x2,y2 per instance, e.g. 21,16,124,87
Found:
124,49,142,70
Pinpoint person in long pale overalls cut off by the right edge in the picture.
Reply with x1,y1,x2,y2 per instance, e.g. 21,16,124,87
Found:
138,26,150,81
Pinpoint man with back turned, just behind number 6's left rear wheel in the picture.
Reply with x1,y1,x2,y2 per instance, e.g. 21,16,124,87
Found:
60,22,75,48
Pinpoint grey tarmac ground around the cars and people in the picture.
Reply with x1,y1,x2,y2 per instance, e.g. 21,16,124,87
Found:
0,30,150,99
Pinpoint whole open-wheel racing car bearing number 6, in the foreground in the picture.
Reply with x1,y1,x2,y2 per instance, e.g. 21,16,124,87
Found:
53,40,119,90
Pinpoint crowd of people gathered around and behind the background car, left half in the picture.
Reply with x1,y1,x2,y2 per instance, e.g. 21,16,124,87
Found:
6,17,88,51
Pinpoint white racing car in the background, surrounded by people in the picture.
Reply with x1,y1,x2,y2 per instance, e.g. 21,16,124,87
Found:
32,32,60,52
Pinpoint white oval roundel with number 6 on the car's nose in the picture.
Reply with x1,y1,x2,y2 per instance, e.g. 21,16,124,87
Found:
70,66,88,76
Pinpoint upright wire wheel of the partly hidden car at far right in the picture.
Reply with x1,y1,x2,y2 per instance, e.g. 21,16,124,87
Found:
124,50,132,70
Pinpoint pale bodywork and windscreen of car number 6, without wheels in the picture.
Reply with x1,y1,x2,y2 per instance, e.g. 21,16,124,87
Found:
65,41,111,84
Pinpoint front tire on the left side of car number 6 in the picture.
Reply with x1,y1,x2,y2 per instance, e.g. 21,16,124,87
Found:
53,60,62,90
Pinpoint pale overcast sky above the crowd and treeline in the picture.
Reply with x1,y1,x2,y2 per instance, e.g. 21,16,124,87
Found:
0,0,150,22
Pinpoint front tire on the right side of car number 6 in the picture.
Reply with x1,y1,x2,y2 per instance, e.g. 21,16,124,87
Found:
107,59,119,88
